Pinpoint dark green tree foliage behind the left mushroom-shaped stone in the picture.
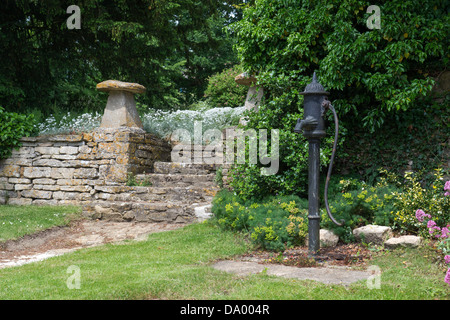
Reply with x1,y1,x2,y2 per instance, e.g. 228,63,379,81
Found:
0,0,240,116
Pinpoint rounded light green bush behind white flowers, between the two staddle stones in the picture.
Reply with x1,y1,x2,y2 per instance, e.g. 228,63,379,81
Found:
204,66,248,108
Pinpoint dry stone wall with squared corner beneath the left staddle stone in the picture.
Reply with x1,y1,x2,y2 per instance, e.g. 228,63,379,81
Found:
0,127,171,205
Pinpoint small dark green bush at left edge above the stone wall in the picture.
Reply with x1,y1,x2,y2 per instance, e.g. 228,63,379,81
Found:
0,107,35,159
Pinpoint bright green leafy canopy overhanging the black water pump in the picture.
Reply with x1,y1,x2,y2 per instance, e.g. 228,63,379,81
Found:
230,0,450,129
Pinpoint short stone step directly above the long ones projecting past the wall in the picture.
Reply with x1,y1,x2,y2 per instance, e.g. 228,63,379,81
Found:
136,173,216,188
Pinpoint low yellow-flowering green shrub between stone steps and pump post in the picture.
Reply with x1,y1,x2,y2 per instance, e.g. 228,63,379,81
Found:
212,190,308,251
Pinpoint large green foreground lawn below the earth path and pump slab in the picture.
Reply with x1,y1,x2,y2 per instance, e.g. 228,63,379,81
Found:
0,212,450,300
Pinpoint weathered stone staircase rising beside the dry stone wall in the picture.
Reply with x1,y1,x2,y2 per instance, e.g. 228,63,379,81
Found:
83,162,222,223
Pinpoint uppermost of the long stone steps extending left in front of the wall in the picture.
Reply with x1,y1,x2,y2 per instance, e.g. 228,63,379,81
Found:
95,186,219,203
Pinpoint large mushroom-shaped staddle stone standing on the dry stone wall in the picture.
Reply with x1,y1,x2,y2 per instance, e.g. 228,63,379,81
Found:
97,80,145,128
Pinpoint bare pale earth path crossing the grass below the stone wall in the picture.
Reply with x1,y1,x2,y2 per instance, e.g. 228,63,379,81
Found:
0,220,185,269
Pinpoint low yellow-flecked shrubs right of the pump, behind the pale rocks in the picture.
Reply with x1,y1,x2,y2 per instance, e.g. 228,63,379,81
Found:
321,170,450,241
